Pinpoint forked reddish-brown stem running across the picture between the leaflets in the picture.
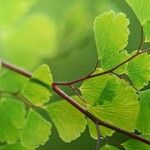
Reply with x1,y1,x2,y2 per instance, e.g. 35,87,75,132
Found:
1,49,150,145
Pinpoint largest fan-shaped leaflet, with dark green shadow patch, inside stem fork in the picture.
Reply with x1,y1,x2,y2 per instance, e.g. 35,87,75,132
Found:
80,75,139,138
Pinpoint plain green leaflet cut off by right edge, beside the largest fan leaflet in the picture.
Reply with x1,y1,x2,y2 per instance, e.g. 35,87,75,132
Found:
137,90,150,134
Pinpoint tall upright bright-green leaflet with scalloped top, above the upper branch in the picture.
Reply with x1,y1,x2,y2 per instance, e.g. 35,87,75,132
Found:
94,11,130,69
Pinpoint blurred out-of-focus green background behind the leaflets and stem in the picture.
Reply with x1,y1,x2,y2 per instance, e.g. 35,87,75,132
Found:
0,0,141,150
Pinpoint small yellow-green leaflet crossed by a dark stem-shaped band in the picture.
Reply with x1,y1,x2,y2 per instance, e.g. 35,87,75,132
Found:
22,65,53,106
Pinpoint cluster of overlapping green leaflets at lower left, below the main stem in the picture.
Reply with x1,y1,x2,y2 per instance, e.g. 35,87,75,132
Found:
0,65,87,150
